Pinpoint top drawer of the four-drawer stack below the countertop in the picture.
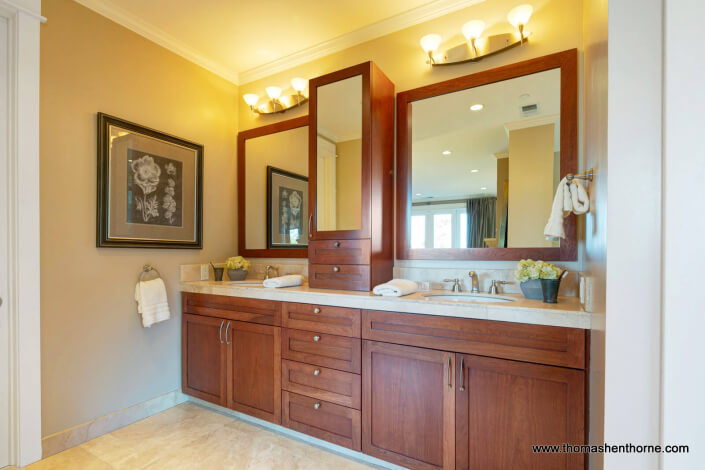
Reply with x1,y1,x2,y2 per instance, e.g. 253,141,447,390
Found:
282,303,360,338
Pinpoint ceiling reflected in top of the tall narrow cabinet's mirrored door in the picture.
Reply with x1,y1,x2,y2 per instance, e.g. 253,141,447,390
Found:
316,75,362,142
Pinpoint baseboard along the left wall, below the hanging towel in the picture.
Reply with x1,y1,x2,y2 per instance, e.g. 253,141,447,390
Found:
42,390,188,459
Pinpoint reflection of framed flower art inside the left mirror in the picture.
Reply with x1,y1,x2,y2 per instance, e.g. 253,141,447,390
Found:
267,166,308,248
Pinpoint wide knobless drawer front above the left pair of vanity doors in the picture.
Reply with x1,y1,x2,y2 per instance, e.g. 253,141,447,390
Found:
181,292,281,326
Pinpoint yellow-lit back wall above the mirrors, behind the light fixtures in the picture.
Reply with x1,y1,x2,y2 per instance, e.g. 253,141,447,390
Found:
239,0,582,130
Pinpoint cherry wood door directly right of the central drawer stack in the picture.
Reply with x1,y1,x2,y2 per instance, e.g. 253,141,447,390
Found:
362,341,454,469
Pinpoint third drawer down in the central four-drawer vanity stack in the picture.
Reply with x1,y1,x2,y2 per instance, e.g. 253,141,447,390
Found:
282,361,361,410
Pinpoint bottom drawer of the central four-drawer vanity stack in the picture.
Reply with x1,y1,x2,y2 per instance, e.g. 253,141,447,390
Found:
282,391,361,451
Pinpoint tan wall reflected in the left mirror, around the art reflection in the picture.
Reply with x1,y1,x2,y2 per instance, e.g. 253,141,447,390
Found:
245,126,308,250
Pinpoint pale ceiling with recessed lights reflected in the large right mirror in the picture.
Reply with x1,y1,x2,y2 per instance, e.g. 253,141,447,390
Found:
411,69,560,201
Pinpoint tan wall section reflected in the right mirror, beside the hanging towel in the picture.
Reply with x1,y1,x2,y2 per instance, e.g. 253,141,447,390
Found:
507,124,555,248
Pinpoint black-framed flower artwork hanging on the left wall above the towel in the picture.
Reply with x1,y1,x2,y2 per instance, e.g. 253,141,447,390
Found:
96,113,203,248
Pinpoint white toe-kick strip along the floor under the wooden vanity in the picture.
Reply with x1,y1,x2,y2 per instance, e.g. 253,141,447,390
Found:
187,397,406,470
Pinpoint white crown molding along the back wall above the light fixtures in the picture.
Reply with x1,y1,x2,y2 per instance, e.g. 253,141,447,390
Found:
236,0,485,84
